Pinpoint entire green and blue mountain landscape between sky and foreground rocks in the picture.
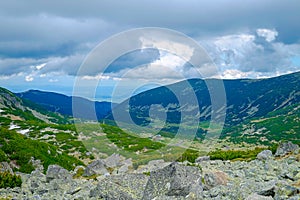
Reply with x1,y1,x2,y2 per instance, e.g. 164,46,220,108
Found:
0,72,300,181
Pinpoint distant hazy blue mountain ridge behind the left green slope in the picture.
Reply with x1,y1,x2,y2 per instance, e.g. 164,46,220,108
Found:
16,90,115,119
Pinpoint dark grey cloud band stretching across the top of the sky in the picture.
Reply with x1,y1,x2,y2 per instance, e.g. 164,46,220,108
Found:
1,0,300,41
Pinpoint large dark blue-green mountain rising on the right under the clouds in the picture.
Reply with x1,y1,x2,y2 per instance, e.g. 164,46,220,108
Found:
106,72,300,143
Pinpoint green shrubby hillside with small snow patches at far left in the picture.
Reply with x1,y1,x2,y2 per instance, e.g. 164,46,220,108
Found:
0,88,88,173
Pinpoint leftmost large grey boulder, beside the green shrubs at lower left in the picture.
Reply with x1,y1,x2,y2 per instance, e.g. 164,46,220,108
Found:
46,165,72,182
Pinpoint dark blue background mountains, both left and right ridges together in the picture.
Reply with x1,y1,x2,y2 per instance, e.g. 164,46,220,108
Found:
2,72,300,146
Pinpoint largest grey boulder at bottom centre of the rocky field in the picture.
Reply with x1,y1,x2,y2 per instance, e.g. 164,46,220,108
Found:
143,163,203,200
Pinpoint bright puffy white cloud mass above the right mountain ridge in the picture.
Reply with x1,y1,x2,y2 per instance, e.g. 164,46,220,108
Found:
200,29,300,78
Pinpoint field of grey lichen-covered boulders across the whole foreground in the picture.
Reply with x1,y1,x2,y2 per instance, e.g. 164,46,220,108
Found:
0,143,300,200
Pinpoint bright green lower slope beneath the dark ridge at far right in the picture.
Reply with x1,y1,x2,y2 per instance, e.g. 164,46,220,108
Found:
222,103,300,144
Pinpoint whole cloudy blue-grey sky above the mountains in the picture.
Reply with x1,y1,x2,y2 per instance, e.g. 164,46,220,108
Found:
0,0,300,102
